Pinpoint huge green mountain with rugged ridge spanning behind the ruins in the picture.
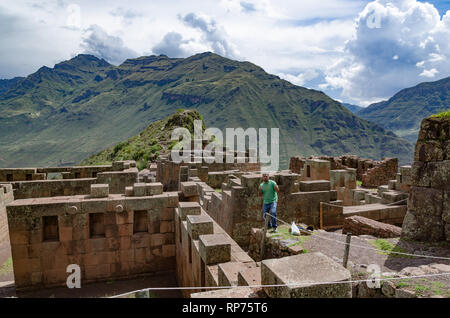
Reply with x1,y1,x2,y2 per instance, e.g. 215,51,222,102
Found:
0,53,412,167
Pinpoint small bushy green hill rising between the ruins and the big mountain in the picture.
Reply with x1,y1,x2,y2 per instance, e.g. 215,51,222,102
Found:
80,110,205,168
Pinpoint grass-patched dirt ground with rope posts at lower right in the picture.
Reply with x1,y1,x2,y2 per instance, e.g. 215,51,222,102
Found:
303,230,450,298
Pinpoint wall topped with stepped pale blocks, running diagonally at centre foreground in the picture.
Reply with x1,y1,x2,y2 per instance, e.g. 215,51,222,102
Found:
175,182,260,297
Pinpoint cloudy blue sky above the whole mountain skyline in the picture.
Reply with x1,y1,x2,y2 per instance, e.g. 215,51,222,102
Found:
0,0,450,106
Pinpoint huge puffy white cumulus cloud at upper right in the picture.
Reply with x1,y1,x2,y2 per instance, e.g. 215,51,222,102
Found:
320,0,450,105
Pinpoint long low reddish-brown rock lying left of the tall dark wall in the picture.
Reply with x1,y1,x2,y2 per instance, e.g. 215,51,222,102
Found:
342,215,402,238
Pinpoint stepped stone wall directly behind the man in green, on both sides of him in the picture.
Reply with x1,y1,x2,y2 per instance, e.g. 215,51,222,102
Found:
203,172,337,247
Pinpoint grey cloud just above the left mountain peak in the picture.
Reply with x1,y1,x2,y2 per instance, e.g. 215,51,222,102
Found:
81,24,138,64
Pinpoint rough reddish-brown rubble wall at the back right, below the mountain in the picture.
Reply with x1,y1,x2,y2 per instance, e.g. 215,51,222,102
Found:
289,155,398,187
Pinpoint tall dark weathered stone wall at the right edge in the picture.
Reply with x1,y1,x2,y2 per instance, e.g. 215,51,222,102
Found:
402,117,450,241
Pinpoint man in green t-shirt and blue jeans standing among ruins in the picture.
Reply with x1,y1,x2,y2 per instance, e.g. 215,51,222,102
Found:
258,173,279,232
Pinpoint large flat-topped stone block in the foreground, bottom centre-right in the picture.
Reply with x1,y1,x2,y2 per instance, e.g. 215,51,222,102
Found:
261,252,352,298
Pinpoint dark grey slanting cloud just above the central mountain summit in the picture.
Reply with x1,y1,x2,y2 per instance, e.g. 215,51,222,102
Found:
179,13,238,58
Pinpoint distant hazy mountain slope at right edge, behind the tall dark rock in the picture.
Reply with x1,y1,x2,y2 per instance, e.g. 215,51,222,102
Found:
358,77,450,143
